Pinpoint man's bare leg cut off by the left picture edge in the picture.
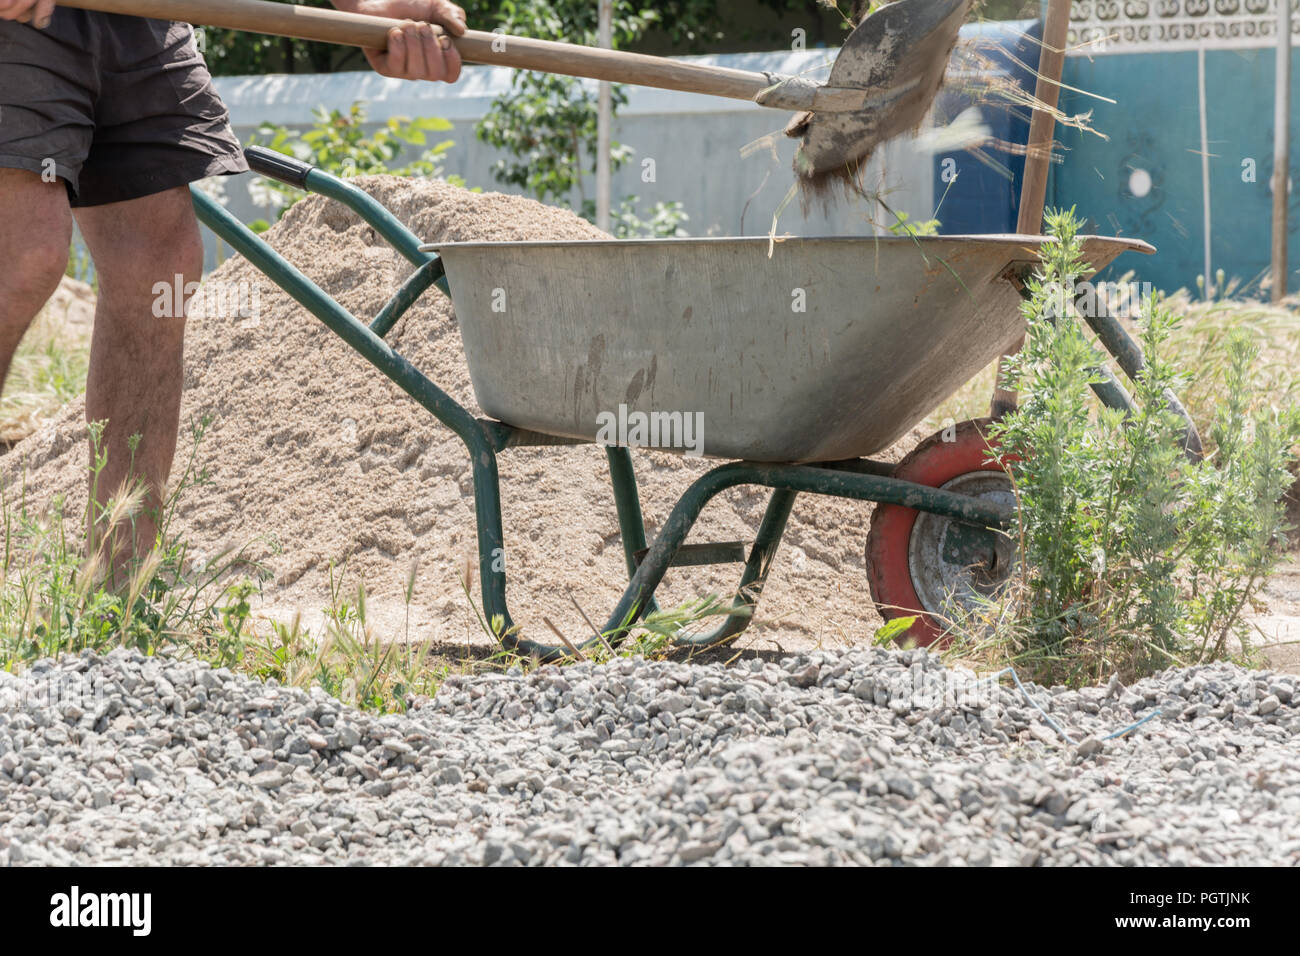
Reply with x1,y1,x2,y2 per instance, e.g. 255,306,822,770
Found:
0,169,73,388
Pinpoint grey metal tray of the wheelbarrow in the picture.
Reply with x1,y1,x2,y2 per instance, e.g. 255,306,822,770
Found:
425,235,1144,462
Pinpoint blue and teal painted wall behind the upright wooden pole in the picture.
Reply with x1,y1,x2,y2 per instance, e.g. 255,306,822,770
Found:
935,25,1300,290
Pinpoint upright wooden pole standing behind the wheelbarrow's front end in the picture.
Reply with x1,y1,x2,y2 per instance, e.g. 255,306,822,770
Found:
989,0,1071,419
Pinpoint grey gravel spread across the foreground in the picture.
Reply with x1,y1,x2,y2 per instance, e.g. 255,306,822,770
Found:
0,649,1300,865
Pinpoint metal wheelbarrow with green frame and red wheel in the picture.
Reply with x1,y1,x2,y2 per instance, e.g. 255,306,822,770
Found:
194,147,1199,659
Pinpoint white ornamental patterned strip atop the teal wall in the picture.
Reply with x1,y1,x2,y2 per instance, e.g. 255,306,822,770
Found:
1070,0,1300,55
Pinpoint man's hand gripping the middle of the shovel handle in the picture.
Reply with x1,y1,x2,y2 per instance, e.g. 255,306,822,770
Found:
335,0,465,83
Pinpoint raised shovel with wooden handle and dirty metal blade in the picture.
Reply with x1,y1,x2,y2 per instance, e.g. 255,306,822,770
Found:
61,0,971,190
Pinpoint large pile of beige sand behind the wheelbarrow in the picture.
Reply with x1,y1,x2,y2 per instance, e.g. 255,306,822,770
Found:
0,177,914,648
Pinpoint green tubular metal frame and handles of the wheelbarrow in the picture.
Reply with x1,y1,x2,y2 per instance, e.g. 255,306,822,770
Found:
194,160,1034,659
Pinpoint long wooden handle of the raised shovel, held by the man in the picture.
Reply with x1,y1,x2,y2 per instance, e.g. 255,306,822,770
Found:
61,0,772,100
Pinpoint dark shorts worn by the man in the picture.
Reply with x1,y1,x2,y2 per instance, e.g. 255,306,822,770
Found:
0,7,248,206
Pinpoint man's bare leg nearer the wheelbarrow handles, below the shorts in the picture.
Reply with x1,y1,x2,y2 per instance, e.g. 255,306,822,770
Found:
77,187,203,568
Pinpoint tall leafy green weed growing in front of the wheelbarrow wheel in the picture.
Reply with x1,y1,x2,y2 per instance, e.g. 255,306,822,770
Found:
992,211,1300,680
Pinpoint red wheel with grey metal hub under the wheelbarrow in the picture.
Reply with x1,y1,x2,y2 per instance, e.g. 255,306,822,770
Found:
867,419,1017,646
